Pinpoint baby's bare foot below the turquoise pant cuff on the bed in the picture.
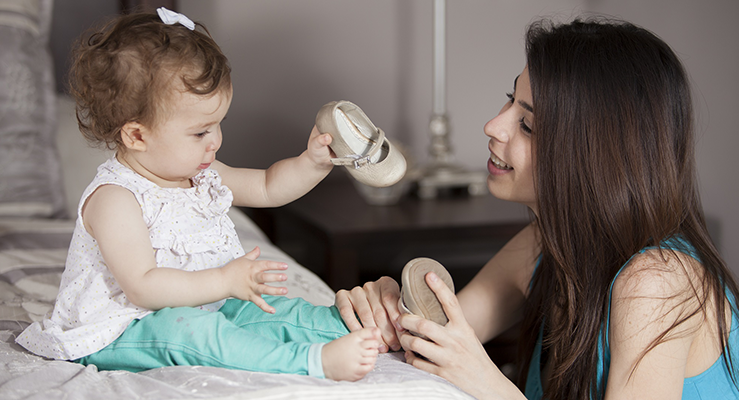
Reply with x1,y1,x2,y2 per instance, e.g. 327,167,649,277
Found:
321,328,381,381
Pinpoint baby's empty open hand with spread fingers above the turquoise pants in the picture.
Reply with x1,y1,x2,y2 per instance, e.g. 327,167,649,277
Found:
223,247,287,314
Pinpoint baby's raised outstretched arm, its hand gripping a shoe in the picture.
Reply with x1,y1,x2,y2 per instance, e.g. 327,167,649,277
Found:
213,127,333,207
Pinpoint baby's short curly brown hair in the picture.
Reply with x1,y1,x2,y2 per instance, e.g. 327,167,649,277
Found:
69,13,231,150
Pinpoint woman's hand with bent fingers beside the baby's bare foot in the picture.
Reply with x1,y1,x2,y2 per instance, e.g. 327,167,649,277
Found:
335,276,403,353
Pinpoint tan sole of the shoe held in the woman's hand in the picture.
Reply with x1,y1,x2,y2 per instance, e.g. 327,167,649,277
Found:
399,257,454,325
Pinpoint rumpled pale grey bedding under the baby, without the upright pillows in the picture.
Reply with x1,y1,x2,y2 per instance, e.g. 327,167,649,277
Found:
0,210,471,400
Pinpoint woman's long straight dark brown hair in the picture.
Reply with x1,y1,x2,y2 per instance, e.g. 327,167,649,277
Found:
520,19,739,400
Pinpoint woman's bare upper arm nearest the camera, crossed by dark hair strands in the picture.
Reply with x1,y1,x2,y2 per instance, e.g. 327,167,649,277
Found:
606,251,722,399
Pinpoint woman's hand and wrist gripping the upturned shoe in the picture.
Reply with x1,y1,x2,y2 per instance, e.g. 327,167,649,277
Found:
399,272,525,399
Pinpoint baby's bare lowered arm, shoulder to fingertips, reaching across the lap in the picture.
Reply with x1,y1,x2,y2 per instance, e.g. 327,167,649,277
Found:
82,185,287,312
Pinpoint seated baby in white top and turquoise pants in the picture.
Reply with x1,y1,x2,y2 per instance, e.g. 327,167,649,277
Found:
17,9,380,380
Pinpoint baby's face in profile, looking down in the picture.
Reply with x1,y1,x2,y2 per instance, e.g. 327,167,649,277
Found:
139,87,232,187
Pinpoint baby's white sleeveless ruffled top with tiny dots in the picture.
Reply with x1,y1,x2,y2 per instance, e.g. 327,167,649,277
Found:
16,157,244,360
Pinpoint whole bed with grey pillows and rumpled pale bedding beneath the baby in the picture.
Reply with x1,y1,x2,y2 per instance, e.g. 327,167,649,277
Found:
0,0,470,399
